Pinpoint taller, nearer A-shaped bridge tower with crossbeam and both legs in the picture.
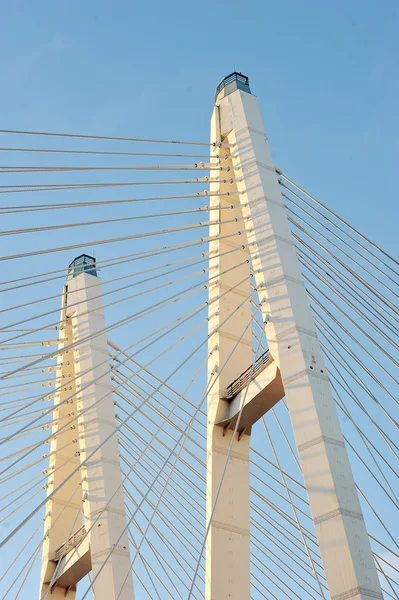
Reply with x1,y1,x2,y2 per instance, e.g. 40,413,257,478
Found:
205,73,382,600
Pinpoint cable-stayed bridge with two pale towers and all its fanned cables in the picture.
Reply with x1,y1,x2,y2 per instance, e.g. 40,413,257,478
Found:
0,73,399,600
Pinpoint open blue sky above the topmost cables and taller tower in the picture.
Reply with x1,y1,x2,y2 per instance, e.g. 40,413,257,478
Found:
0,0,399,252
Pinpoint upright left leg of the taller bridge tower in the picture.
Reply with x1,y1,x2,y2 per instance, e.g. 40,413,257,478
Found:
205,105,252,600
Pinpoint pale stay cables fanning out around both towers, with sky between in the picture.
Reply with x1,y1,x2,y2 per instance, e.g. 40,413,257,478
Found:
0,130,399,600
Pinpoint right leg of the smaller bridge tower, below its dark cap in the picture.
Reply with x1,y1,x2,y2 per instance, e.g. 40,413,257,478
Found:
67,272,134,600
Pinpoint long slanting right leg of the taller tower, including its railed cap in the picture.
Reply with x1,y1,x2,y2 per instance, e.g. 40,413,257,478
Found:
211,74,382,600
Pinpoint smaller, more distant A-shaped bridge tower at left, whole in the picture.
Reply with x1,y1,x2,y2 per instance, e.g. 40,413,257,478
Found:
39,254,134,600
